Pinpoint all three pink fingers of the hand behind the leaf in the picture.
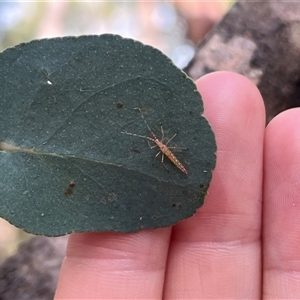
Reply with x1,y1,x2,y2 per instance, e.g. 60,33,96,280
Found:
55,72,300,299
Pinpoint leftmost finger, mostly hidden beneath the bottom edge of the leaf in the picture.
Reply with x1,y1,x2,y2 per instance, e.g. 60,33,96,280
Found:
55,228,171,299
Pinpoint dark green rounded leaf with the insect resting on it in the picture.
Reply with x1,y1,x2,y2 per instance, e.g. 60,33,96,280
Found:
0,34,216,236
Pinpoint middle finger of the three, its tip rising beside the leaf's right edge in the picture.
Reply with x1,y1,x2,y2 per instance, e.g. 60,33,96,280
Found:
165,72,265,299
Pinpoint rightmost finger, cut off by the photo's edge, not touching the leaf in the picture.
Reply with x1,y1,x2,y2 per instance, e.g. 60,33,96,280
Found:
263,108,300,299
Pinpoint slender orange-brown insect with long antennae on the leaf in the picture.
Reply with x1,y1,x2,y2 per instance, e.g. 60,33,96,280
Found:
121,108,188,174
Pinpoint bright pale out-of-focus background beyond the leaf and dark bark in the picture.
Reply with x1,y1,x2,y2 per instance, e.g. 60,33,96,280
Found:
0,0,235,262
